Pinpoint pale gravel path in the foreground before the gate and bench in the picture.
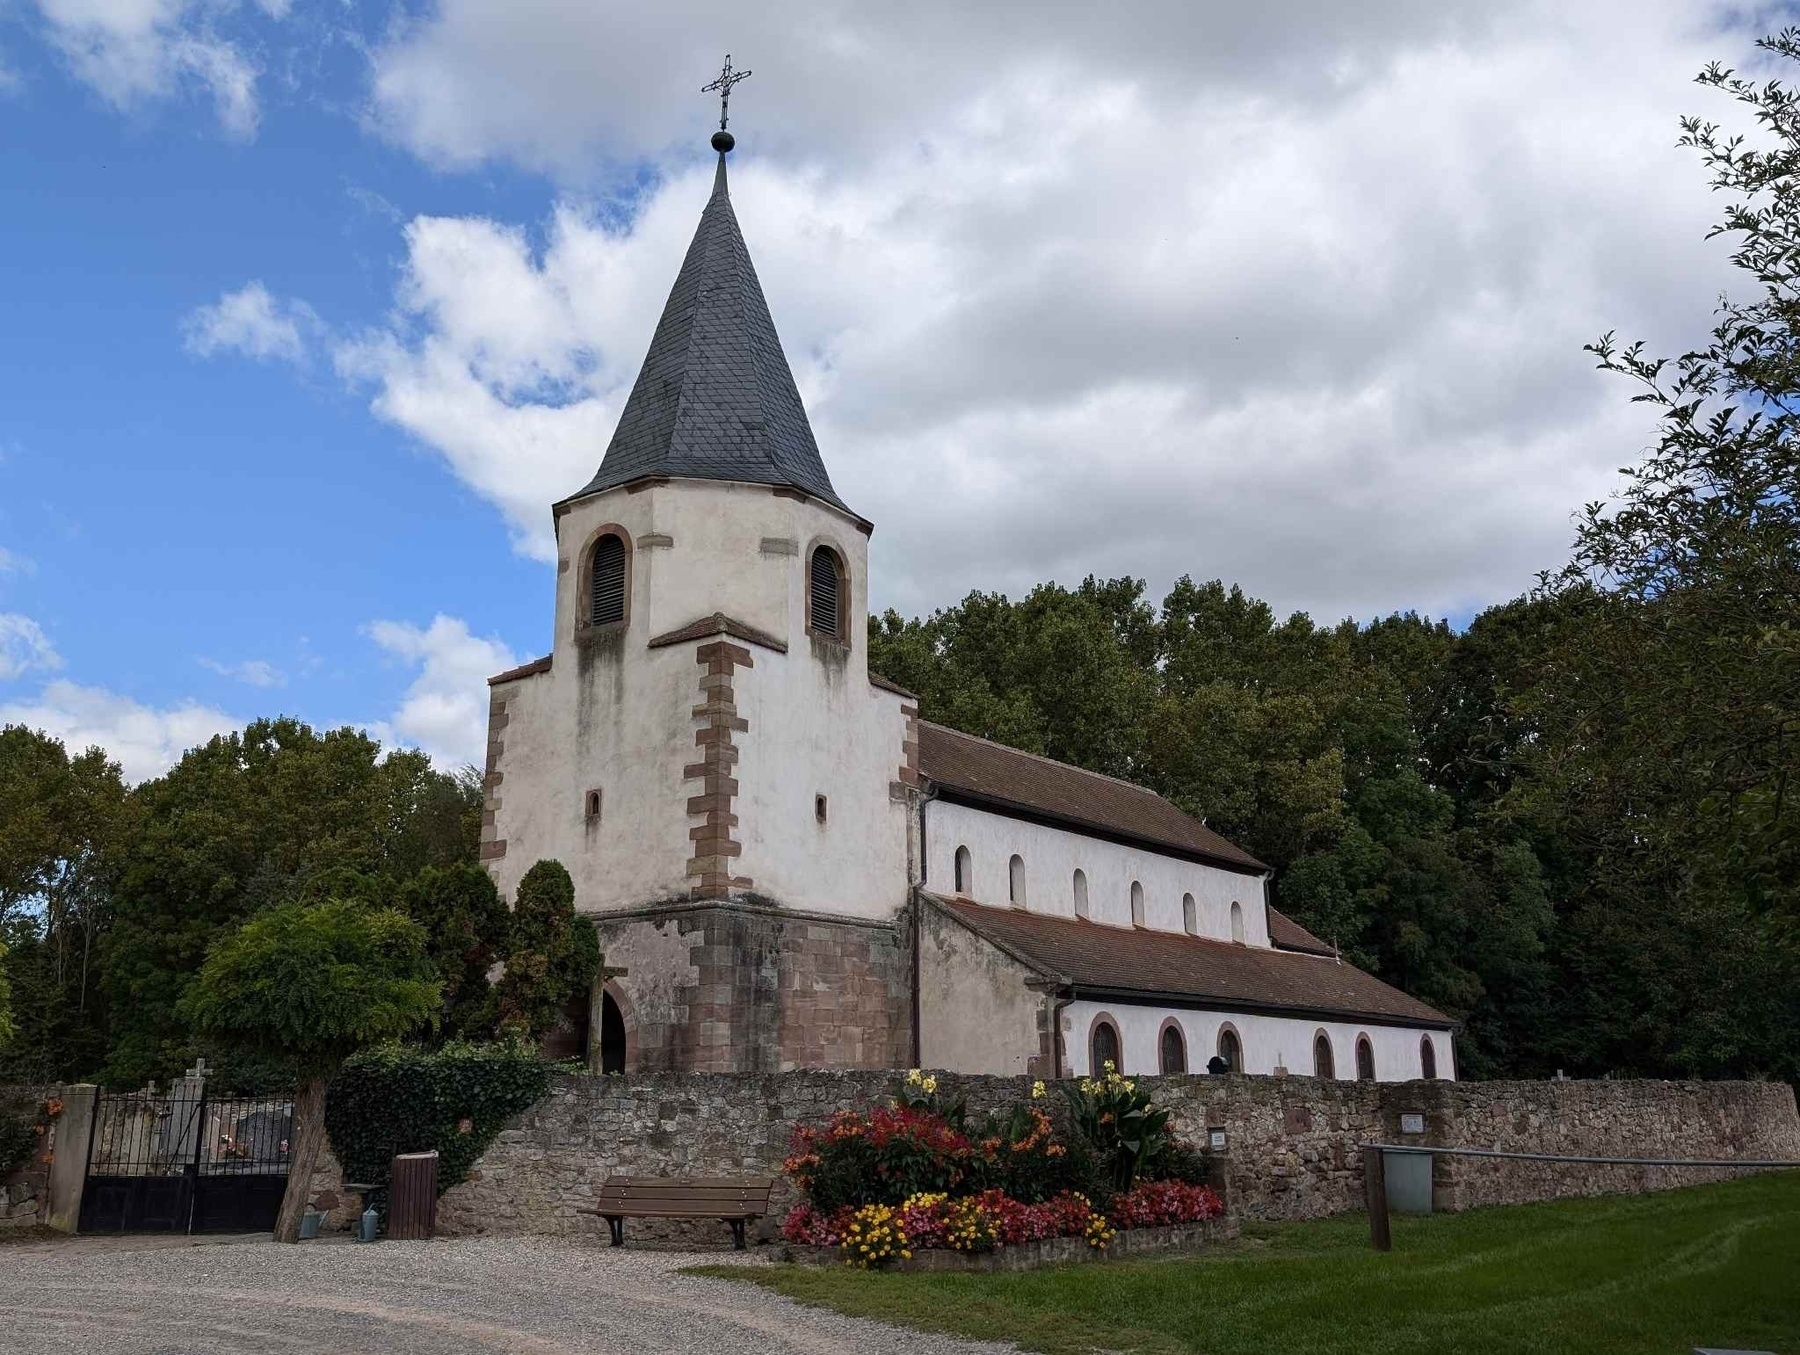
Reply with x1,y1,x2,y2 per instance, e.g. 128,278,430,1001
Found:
0,1238,1013,1355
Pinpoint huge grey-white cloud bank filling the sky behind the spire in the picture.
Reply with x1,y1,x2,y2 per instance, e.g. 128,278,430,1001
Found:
338,0,1753,619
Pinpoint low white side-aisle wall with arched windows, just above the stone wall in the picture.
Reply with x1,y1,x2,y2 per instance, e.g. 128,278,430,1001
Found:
1062,1000,1456,1081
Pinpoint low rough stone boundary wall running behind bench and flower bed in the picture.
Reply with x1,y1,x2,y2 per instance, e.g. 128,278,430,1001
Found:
437,1072,1800,1245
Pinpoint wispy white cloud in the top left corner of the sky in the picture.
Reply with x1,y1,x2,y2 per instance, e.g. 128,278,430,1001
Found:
36,0,264,139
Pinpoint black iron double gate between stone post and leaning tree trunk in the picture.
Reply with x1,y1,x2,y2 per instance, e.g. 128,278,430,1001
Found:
81,1083,293,1233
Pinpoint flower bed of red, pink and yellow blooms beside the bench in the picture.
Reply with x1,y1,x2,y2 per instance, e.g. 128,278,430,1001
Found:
781,1069,1226,1269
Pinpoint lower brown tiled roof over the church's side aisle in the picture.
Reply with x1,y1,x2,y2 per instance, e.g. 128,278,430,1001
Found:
922,891,1453,1026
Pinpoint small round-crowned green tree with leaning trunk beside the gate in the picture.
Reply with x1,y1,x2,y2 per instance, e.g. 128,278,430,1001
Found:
180,900,443,1242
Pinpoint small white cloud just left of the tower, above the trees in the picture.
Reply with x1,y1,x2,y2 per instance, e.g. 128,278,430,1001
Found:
367,615,517,770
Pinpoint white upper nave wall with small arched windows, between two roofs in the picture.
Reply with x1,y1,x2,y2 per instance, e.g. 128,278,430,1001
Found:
925,801,1269,947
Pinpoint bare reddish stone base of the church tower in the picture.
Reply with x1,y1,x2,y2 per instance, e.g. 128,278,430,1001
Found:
590,903,913,1072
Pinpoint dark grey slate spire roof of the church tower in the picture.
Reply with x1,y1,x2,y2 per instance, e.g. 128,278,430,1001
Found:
572,153,855,516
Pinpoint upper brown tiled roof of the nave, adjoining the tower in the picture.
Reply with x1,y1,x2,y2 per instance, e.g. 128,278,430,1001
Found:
918,720,1269,873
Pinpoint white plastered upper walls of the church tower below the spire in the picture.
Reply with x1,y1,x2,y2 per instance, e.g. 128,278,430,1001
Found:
491,480,907,916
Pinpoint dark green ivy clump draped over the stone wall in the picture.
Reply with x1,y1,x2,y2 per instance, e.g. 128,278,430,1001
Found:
326,1042,562,1213
